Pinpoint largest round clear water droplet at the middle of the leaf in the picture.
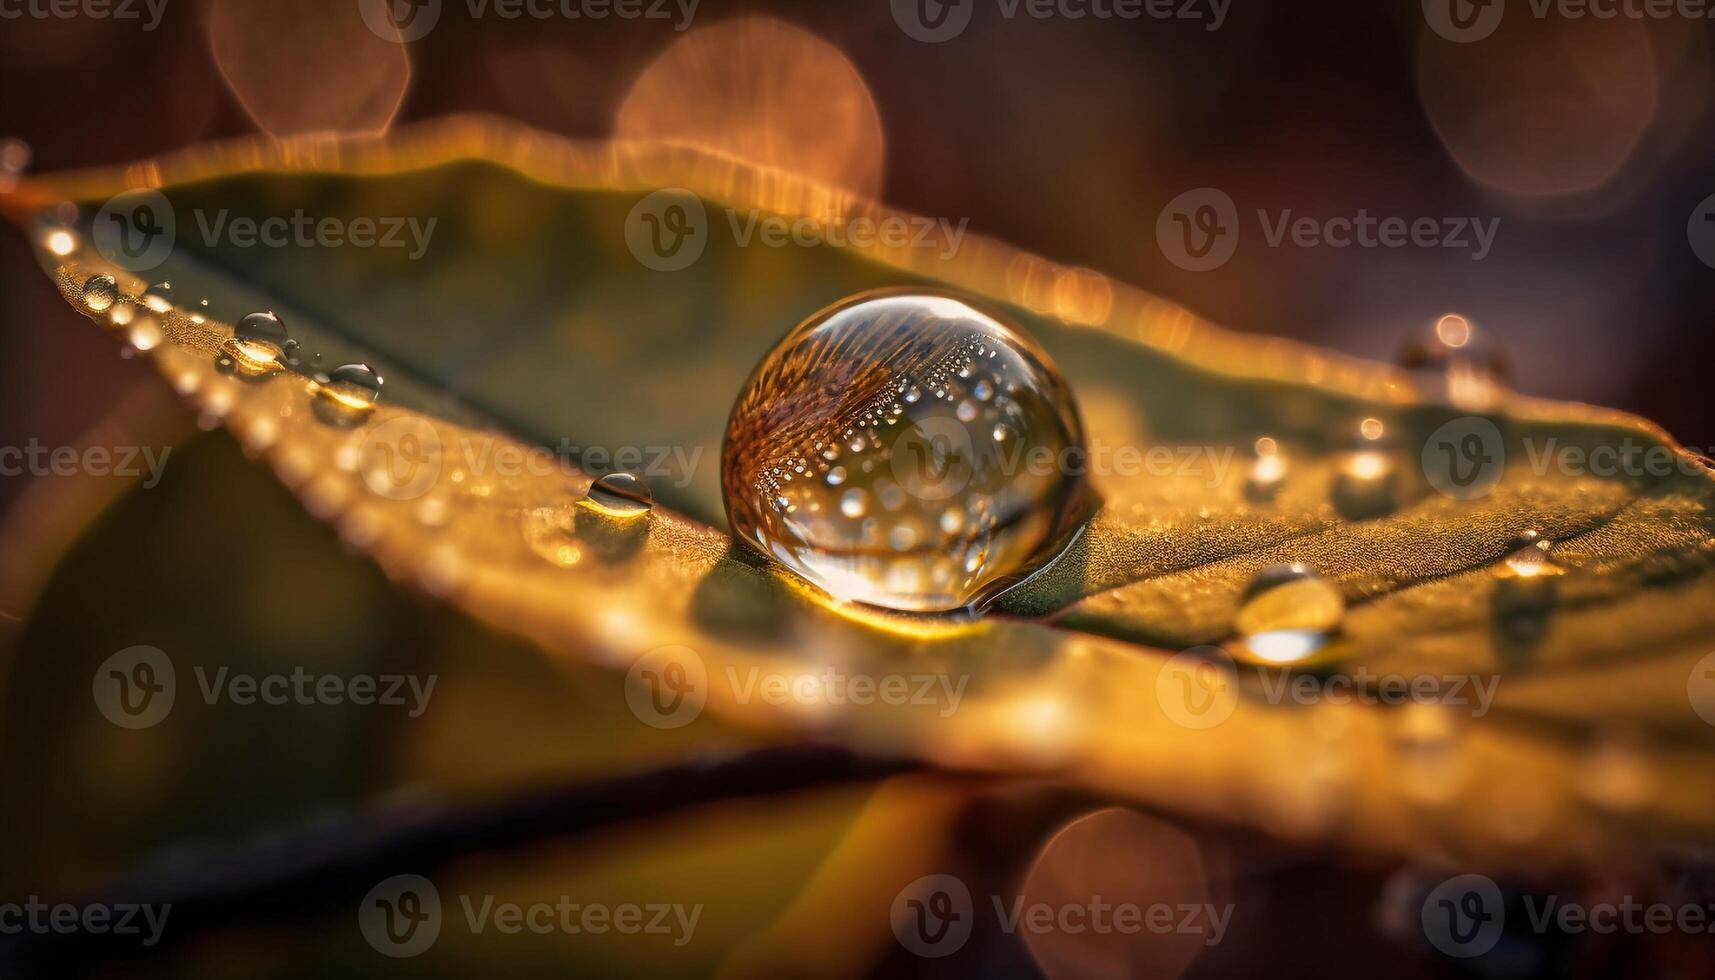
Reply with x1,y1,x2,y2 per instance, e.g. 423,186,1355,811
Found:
722,293,1086,611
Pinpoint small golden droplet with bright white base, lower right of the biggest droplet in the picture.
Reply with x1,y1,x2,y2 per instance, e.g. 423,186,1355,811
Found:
1233,565,1346,664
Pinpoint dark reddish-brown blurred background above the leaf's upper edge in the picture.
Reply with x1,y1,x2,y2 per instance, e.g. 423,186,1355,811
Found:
0,0,1715,528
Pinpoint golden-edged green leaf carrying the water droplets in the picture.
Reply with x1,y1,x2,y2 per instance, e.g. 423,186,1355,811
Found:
7,120,1715,867
